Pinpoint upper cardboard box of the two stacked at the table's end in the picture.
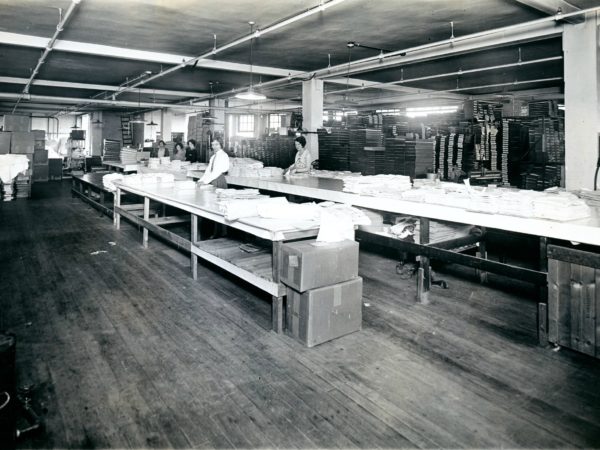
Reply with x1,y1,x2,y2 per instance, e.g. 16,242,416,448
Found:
279,239,358,292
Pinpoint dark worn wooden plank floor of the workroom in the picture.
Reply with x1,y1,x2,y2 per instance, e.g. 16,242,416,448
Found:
0,182,600,448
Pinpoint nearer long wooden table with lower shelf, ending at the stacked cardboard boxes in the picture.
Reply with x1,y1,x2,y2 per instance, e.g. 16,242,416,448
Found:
114,183,319,332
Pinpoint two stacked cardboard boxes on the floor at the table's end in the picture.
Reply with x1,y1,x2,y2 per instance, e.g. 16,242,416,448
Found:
279,240,362,347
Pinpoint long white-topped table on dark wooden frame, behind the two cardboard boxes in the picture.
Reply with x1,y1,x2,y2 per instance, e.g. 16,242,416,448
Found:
227,176,600,343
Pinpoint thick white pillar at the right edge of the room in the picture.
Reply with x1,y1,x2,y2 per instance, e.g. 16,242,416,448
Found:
563,15,600,190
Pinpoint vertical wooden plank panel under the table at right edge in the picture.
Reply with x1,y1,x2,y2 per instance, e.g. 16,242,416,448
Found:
548,245,600,358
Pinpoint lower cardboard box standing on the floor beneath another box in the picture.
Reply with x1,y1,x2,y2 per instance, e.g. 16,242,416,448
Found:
286,277,362,347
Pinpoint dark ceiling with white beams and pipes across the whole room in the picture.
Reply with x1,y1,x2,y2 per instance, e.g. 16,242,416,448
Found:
0,0,600,115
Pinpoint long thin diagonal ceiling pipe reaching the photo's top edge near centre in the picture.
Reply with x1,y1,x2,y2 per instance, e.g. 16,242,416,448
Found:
110,0,345,99
